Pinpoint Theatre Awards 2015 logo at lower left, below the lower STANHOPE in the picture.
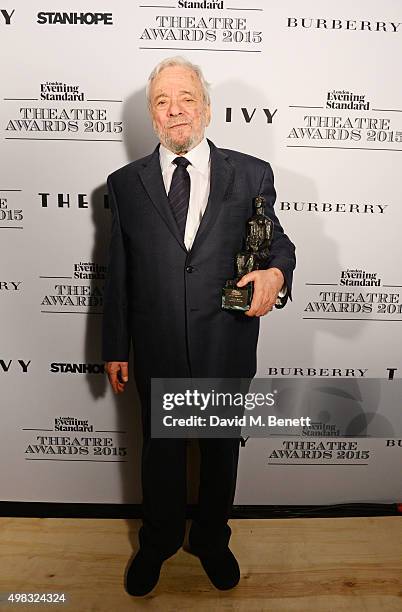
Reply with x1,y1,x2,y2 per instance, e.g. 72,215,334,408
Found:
23,416,127,462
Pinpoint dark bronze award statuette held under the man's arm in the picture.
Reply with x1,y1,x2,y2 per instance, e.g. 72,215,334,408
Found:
222,196,280,311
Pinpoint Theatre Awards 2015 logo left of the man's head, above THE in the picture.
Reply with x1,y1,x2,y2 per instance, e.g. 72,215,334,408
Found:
4,80,123,142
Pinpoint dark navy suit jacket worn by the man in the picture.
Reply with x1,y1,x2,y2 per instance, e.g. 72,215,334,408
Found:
102,141,295,384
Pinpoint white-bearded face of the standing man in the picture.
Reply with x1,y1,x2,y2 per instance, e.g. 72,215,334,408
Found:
150,66,211,154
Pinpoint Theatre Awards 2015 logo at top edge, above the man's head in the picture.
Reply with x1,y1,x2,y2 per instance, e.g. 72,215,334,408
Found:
138,0,264,52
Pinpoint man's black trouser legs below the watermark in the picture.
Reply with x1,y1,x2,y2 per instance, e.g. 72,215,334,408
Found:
139,384,240,559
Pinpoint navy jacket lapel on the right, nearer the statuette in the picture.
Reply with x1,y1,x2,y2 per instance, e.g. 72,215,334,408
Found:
191,140,234,251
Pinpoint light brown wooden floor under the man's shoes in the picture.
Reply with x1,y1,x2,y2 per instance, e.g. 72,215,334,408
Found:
0,516,402,612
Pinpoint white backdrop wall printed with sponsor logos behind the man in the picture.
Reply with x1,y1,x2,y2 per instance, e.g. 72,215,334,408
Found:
0,0,402,504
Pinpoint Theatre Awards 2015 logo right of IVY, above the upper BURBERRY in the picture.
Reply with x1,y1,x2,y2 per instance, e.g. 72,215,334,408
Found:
287,89,402,150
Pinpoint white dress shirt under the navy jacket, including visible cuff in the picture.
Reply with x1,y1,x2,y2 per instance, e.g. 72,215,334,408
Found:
159,138,286,297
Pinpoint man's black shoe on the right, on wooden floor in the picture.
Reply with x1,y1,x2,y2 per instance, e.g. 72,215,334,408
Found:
187,548,240,591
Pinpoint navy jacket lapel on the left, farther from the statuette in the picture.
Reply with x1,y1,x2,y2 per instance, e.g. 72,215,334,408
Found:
139,145,187,252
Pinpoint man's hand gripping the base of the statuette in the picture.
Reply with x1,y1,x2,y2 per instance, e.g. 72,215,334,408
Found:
237,268,285,317
